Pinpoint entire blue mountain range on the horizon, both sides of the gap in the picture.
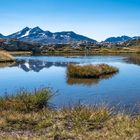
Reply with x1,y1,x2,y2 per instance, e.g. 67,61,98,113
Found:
0,26,140,44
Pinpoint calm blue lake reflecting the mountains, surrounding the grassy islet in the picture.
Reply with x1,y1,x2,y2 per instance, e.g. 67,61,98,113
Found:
0,55,140,111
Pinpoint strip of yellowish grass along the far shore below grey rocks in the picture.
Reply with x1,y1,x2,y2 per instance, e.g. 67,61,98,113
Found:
6,46,140,56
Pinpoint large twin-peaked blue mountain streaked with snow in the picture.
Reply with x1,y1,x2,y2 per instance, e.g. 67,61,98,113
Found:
6,27,96,44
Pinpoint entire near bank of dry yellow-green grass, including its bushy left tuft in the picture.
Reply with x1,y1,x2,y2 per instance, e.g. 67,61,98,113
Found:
0,89,140,140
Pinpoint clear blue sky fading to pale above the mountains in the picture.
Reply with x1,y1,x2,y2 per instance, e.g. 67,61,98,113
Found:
0,0,140,41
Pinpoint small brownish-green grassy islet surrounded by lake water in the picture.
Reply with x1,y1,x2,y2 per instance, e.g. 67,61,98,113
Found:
67,64,118,78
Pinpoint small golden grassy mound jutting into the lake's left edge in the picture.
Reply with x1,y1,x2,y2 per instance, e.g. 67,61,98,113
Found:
0,51,15,62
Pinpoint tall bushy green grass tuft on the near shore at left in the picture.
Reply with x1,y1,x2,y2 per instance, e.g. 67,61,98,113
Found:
0,88,53,112
